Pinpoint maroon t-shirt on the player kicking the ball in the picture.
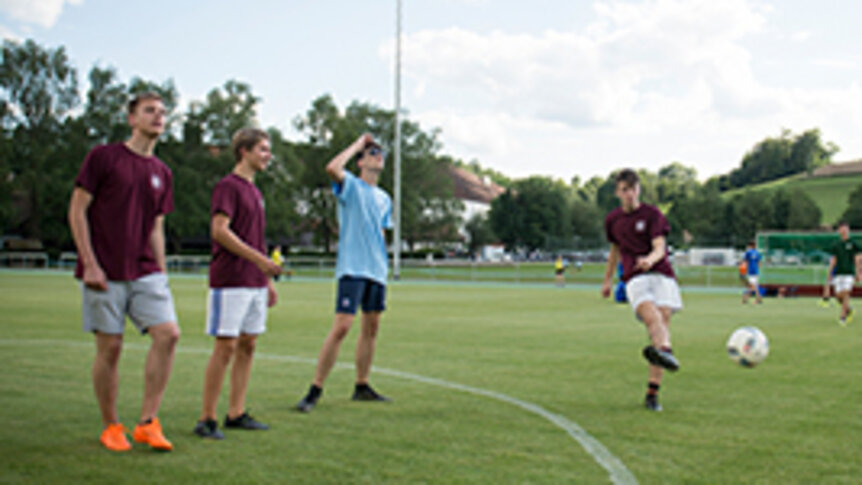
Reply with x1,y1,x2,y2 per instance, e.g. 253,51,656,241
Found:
605,204,676,281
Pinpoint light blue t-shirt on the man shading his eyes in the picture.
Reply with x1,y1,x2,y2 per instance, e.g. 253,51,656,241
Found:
332,171,392,285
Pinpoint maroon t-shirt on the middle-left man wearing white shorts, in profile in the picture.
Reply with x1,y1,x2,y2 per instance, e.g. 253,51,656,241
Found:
210,173,267,288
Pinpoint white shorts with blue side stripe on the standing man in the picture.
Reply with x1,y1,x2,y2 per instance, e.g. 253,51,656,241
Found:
206,287,268,337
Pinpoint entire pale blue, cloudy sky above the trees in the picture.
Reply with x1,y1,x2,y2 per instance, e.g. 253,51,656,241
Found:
0,0,862,181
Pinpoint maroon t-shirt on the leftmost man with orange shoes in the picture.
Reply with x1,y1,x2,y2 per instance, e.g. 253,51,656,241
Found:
75,143,174,281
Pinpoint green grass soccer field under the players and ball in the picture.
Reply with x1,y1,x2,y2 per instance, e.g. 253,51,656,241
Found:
0,272,862,484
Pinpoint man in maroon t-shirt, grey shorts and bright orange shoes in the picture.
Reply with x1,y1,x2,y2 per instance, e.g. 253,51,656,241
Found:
69,92,180,451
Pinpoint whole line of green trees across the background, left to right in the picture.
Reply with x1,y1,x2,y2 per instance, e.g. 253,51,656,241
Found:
0,40,862,260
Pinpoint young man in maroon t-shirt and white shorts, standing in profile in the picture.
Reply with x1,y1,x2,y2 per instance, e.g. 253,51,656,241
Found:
194,128,281,439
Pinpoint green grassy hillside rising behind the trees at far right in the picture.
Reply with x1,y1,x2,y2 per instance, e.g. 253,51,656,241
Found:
721,174,862,224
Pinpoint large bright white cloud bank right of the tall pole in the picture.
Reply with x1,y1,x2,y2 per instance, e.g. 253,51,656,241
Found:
379,0,862,178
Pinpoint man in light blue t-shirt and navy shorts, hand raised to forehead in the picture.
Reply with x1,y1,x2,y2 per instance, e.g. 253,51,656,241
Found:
296,134,392,412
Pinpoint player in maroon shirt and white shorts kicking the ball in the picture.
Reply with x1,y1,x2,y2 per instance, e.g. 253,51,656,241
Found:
602,169,682,411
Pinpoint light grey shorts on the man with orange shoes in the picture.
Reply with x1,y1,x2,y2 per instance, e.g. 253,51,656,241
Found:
81,273,177,335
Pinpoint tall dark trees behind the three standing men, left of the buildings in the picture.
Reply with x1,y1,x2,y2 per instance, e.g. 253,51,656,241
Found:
0,40,462,252
